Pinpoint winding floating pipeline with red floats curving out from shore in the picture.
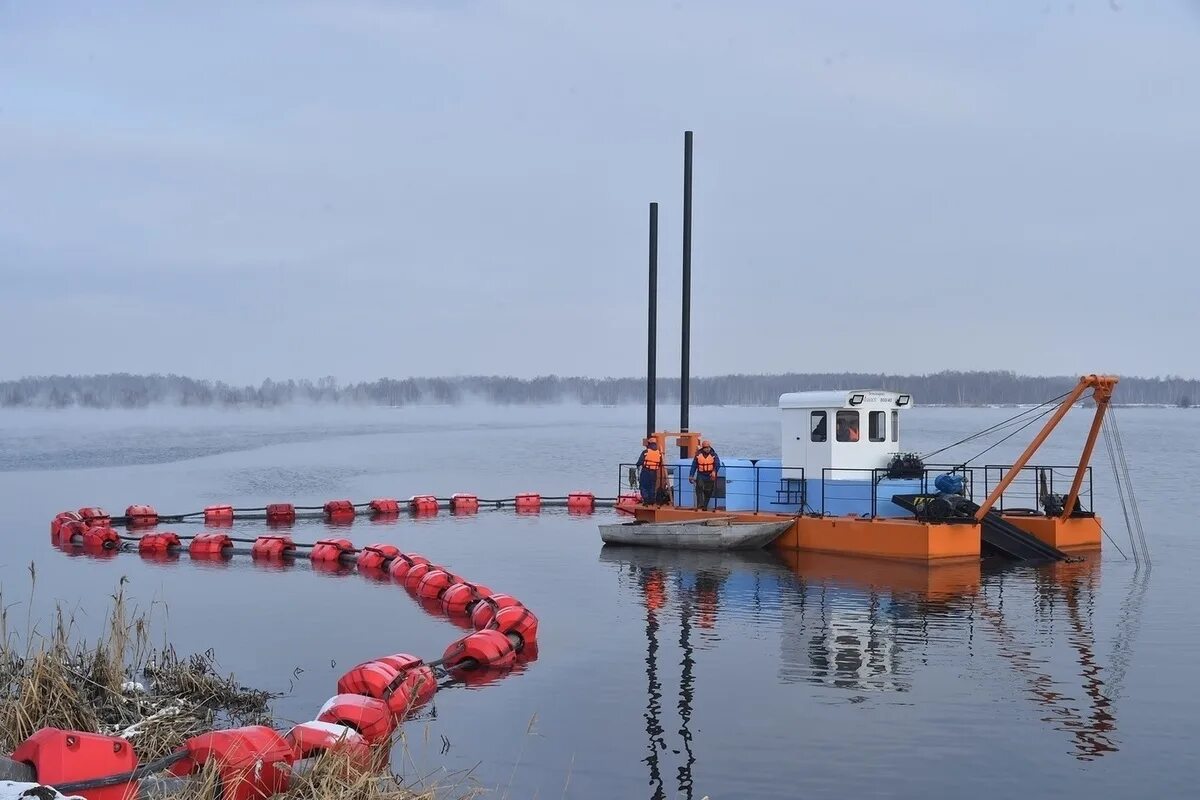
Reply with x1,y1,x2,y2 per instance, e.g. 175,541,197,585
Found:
18,513,542,800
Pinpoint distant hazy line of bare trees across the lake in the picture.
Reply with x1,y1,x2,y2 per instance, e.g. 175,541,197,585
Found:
0,372,1200,409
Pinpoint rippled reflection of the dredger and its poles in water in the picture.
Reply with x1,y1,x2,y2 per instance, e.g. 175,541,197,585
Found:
600,546,1145,767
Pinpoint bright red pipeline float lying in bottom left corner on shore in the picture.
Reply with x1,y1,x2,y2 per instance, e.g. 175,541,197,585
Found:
12,728,138,800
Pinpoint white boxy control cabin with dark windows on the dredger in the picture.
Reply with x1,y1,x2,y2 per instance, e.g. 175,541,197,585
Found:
779,390,912,480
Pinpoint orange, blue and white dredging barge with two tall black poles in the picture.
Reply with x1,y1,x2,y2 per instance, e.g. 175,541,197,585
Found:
606,132,1137,564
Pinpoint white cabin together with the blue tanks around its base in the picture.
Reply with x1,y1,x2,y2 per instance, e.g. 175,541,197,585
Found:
673,390,919,516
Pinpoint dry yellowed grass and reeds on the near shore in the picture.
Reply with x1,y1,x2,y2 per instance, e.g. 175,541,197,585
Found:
0,565,479,800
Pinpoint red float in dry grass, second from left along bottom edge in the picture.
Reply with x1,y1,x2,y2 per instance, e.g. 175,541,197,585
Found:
170,726,295,800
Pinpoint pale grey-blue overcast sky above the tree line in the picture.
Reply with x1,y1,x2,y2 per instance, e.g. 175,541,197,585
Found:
0,0,1200,383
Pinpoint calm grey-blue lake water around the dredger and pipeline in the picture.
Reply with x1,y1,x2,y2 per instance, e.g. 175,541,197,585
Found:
0,407,1200,799
